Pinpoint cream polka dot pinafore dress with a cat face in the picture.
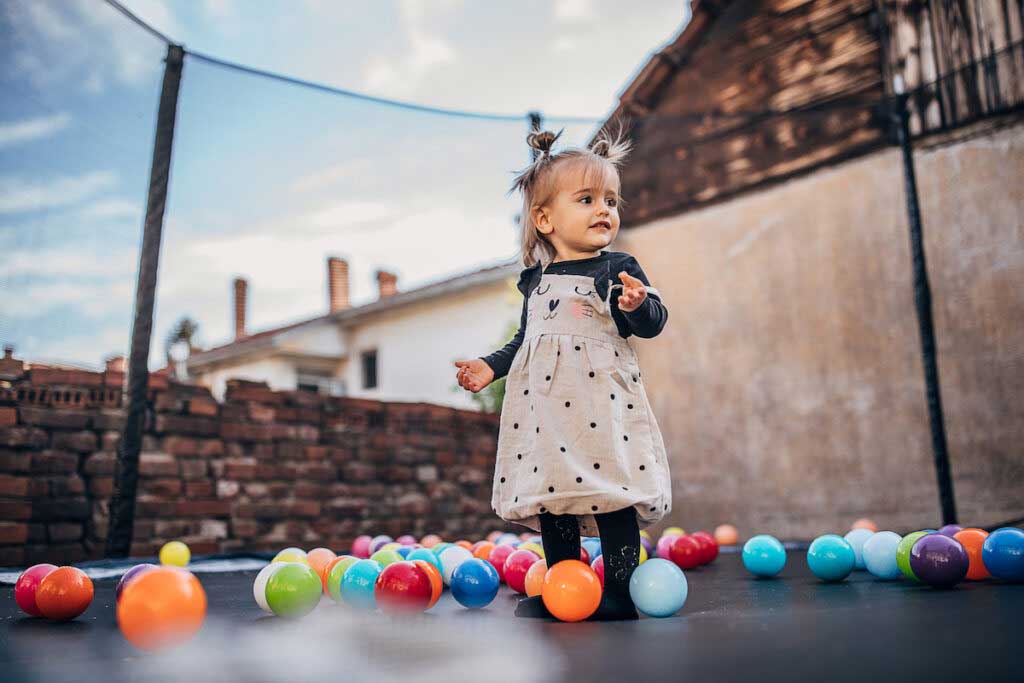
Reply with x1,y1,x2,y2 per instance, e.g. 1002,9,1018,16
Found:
492,259,672,536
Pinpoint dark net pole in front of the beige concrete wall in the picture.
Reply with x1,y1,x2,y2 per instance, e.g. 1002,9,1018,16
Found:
890,76,956,524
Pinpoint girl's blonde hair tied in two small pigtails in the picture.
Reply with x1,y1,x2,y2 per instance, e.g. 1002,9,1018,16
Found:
509,122,633,268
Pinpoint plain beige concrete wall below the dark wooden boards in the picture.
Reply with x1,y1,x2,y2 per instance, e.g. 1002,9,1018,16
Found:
616,123,1024,538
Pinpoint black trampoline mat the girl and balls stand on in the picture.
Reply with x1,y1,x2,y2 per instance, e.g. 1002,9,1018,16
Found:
0,551,1024,683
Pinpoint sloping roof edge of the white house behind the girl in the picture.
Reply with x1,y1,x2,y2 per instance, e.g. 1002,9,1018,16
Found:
186,254,521,370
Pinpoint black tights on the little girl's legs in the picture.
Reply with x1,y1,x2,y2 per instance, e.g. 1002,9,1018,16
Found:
540,507,640,595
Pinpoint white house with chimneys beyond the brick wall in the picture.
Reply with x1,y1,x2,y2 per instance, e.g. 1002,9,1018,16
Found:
186,257,522,410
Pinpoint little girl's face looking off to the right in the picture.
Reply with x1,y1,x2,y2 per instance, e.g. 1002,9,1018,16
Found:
535,163,618,258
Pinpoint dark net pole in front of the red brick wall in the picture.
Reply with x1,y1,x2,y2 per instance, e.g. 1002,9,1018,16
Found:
105,44,184,557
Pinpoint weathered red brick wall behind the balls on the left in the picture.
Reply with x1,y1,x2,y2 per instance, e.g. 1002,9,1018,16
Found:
0,369,499,566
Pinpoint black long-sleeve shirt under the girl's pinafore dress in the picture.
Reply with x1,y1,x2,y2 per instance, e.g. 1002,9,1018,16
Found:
480,251,669,380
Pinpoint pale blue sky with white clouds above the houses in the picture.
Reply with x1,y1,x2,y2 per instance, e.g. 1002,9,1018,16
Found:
0,0,689,370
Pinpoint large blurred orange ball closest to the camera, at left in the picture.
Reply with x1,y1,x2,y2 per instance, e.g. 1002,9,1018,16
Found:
118,566,206,650
